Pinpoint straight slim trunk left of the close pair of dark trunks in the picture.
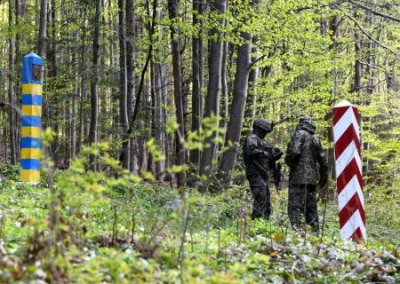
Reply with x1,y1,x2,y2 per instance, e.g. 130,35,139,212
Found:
89,0,102,170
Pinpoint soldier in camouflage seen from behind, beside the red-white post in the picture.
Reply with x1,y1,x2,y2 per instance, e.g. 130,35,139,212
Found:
285,118,328,233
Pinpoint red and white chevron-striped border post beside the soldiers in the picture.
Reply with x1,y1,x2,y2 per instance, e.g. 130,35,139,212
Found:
332,100,367,241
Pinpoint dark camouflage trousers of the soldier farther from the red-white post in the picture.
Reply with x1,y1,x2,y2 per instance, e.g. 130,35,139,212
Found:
247,174,271,220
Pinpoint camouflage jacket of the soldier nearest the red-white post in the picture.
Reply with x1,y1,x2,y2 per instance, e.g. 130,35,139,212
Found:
285,128,328,185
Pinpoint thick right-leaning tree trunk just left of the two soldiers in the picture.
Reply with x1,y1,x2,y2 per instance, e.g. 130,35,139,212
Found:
219,33,251,185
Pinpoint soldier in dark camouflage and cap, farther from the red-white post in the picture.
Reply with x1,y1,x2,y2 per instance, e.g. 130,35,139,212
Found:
243,119,283,219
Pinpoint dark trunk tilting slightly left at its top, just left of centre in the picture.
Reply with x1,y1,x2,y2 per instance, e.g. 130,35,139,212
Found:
168,0,186,187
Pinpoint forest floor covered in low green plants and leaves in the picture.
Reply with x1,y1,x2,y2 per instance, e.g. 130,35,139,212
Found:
0,165,400,284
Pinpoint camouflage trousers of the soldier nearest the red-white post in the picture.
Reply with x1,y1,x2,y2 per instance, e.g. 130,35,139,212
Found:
288,184,319,233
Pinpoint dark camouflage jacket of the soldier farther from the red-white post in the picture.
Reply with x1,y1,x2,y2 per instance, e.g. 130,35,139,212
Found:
243,133,272,180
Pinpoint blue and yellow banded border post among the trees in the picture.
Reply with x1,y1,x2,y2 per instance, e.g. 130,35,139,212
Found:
20,52,43,183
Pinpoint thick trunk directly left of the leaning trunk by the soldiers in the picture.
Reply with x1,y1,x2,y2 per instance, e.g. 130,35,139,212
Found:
200,0,226,191
